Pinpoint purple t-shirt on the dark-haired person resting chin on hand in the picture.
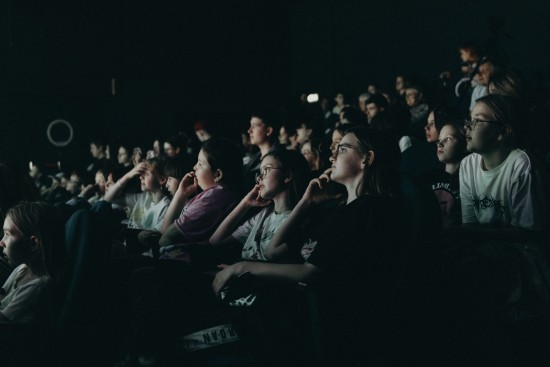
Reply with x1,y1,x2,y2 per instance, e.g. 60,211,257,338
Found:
174,185,238,243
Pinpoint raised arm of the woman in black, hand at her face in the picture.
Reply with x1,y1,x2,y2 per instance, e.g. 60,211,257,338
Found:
264,169,332,261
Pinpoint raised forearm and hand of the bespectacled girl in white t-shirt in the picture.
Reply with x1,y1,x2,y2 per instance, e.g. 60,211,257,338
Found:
209,185,270,245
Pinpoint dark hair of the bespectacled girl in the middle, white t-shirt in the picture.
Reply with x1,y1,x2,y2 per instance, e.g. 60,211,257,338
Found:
264,149,311,207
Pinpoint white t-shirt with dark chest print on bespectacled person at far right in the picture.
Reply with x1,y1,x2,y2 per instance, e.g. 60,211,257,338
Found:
460,149,543,230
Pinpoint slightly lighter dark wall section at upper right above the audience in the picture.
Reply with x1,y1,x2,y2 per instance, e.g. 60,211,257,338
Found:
290,0,550,98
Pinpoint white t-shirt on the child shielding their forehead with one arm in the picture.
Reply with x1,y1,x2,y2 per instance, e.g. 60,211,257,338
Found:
125,192,170,232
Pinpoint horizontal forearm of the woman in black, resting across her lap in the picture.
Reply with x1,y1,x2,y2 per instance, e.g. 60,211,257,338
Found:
212,261,320,294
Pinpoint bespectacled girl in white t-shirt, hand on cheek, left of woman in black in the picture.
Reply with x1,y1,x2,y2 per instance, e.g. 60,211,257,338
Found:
210,150,310,261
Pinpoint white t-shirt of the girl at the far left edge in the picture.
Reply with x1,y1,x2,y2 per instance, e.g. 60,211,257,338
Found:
0,264,52,322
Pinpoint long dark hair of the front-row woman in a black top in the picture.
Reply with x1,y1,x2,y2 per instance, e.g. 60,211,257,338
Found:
346,127,401,197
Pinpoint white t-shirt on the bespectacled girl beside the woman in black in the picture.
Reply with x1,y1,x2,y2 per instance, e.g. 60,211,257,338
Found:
232,206,290,260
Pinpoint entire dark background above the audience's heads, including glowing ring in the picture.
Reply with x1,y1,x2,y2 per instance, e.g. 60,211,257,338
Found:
0,0,550,170
